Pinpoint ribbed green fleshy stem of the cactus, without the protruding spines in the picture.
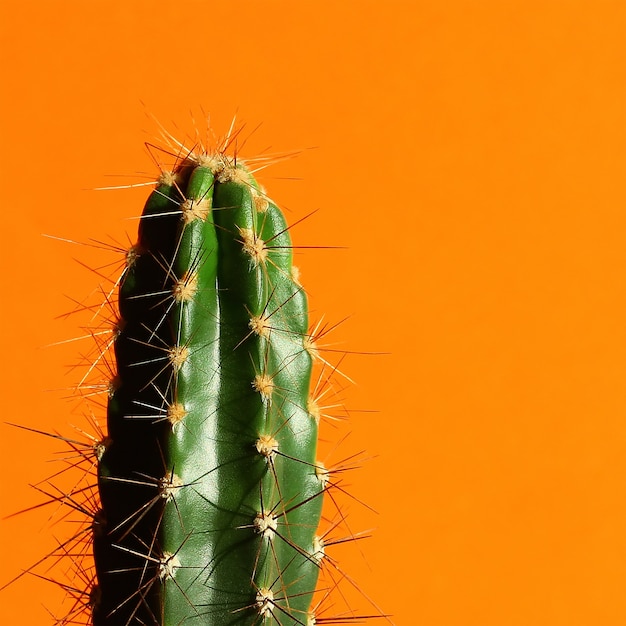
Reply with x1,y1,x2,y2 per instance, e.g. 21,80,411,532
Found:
92,157,325,626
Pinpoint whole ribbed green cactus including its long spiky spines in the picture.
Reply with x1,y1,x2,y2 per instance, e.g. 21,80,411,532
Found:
0,128,391,626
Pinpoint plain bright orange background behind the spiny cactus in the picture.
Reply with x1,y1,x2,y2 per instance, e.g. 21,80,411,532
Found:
0,0,626,626
